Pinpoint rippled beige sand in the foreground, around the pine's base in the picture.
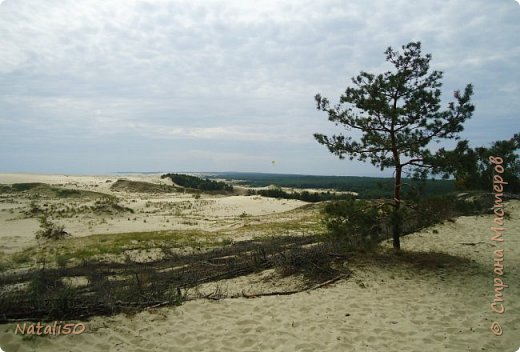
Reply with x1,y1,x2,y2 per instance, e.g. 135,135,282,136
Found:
0,175,520,352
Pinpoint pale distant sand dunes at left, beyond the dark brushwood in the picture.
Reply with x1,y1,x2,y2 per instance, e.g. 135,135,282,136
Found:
0,174,306,254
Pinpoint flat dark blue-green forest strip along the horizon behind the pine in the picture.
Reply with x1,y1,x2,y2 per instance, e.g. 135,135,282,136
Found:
207,172,455,199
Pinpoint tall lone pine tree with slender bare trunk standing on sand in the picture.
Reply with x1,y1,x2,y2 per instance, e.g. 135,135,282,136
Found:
314,42,474,249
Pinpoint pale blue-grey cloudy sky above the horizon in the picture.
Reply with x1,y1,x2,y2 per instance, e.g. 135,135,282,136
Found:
0,0,520,176
